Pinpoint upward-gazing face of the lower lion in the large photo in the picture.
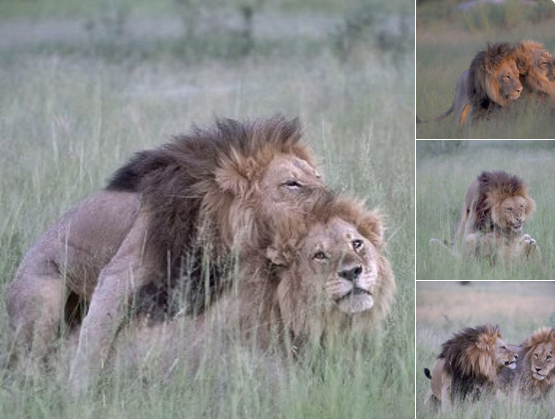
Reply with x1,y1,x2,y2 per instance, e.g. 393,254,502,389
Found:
288,218,378,314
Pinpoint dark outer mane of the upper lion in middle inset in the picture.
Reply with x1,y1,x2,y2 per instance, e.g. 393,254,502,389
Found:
474,170,526,232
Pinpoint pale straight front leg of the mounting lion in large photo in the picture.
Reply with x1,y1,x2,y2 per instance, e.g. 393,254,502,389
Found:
69,217,151,396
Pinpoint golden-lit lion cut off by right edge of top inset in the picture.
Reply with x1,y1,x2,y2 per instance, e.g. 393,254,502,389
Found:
514,40,555,104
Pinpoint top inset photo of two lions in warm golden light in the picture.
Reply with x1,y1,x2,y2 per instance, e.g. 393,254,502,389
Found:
416,0,555,139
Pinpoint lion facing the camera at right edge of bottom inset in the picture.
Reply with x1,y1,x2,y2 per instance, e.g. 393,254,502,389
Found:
502,327,555,400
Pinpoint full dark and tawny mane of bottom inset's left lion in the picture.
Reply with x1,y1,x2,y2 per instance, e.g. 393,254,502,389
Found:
438,324,512,400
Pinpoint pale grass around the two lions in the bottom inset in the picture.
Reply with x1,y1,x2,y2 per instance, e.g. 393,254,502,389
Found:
416,281,555,419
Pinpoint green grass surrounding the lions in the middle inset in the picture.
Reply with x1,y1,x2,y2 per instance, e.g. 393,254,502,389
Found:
416,140,555,280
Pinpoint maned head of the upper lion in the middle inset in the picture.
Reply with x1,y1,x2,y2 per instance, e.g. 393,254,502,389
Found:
474,171,536,235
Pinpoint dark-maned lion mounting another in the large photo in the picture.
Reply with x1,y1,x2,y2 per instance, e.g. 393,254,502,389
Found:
5,116,324,393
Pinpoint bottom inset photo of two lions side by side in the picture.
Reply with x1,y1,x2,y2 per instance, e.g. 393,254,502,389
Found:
416,281,556,419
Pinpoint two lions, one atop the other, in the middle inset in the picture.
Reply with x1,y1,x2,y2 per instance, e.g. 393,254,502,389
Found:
430,171,541,265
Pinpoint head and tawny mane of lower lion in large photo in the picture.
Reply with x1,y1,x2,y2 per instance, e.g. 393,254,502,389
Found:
238,197,395,352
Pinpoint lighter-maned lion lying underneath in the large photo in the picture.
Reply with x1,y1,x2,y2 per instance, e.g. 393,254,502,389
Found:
69,194,396,378
